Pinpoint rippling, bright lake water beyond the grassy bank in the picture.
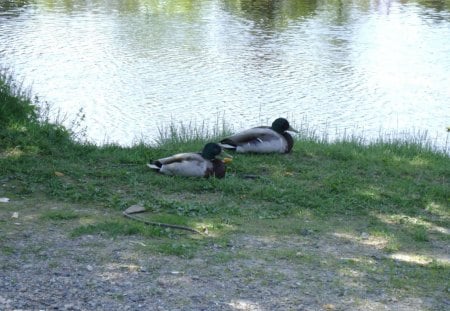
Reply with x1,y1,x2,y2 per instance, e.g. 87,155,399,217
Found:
0,0,450,149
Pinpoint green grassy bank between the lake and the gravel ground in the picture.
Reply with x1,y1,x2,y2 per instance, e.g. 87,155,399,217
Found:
0,73,450,306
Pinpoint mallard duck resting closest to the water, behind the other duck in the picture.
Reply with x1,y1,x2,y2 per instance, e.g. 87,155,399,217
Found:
220,118,298,153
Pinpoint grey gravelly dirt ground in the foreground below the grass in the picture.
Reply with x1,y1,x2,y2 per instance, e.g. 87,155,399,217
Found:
0,201,450,310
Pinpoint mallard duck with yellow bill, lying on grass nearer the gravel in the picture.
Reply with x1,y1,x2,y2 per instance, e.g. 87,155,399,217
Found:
147,143,231,178
